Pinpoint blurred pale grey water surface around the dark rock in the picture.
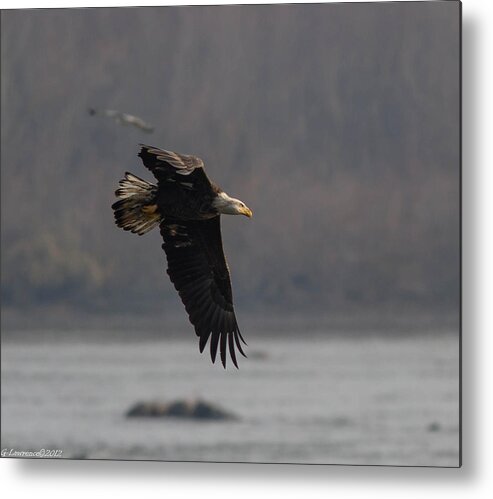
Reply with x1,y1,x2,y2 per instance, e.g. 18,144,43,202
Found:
2,333,459,466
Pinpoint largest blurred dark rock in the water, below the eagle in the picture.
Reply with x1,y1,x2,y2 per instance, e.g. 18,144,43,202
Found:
126,400,236,421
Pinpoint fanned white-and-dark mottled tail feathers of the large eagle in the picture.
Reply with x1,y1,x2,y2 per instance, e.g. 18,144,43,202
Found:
112,172,162,236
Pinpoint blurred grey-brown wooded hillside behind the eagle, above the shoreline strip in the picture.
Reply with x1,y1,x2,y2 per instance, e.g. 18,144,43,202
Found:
1,2,460,328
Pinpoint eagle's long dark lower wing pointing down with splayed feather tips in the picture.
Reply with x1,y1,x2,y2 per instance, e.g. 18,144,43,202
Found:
160,217,245,367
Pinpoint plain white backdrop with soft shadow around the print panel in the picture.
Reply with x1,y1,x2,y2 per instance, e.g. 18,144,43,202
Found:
0,0,493,499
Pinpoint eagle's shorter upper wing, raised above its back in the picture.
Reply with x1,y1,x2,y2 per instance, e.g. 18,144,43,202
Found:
139,144,212,189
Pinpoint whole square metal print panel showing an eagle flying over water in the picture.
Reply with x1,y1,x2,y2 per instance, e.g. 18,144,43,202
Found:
1,1,461,467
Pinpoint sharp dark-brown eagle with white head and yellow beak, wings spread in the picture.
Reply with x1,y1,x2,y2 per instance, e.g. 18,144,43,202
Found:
112,144,252,367
